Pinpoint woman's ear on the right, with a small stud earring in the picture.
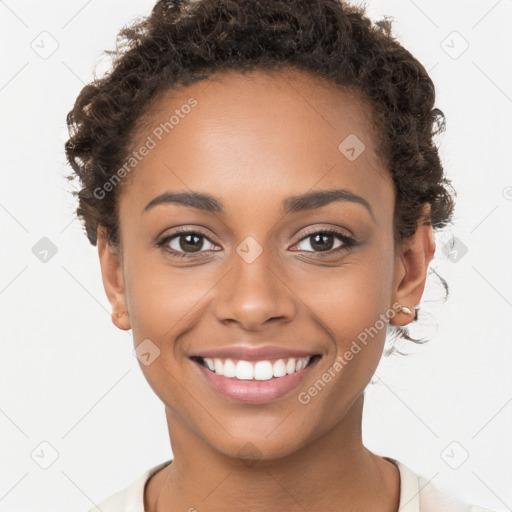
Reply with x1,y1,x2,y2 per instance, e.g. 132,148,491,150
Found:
389,203,436,325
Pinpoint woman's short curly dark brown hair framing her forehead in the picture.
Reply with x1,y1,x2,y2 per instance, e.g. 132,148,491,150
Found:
65,0,456,348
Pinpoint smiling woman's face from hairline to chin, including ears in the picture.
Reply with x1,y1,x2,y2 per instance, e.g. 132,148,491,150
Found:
98,67,430,459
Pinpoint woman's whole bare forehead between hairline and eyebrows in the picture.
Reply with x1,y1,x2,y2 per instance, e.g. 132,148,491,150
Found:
119,69,392,219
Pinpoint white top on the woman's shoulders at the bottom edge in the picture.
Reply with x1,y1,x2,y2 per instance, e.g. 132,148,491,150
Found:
89,457,492,512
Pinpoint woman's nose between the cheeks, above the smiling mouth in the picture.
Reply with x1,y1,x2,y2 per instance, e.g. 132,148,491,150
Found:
215,245,296,331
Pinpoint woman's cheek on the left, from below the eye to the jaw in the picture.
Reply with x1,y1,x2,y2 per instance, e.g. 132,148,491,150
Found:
125,253,212,410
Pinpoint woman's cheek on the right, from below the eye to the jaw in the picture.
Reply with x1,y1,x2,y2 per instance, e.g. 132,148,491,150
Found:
292,255,392,412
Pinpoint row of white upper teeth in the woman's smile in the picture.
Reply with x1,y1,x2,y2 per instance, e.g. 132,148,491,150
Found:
204,357,311,380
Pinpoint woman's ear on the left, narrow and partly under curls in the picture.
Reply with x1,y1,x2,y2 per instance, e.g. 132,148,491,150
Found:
97,226,131,331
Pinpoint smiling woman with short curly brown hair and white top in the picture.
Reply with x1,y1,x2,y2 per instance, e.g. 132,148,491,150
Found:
66,0,492,512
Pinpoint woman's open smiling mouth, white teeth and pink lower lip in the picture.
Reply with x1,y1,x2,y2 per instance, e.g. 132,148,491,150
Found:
190,354,322,405
